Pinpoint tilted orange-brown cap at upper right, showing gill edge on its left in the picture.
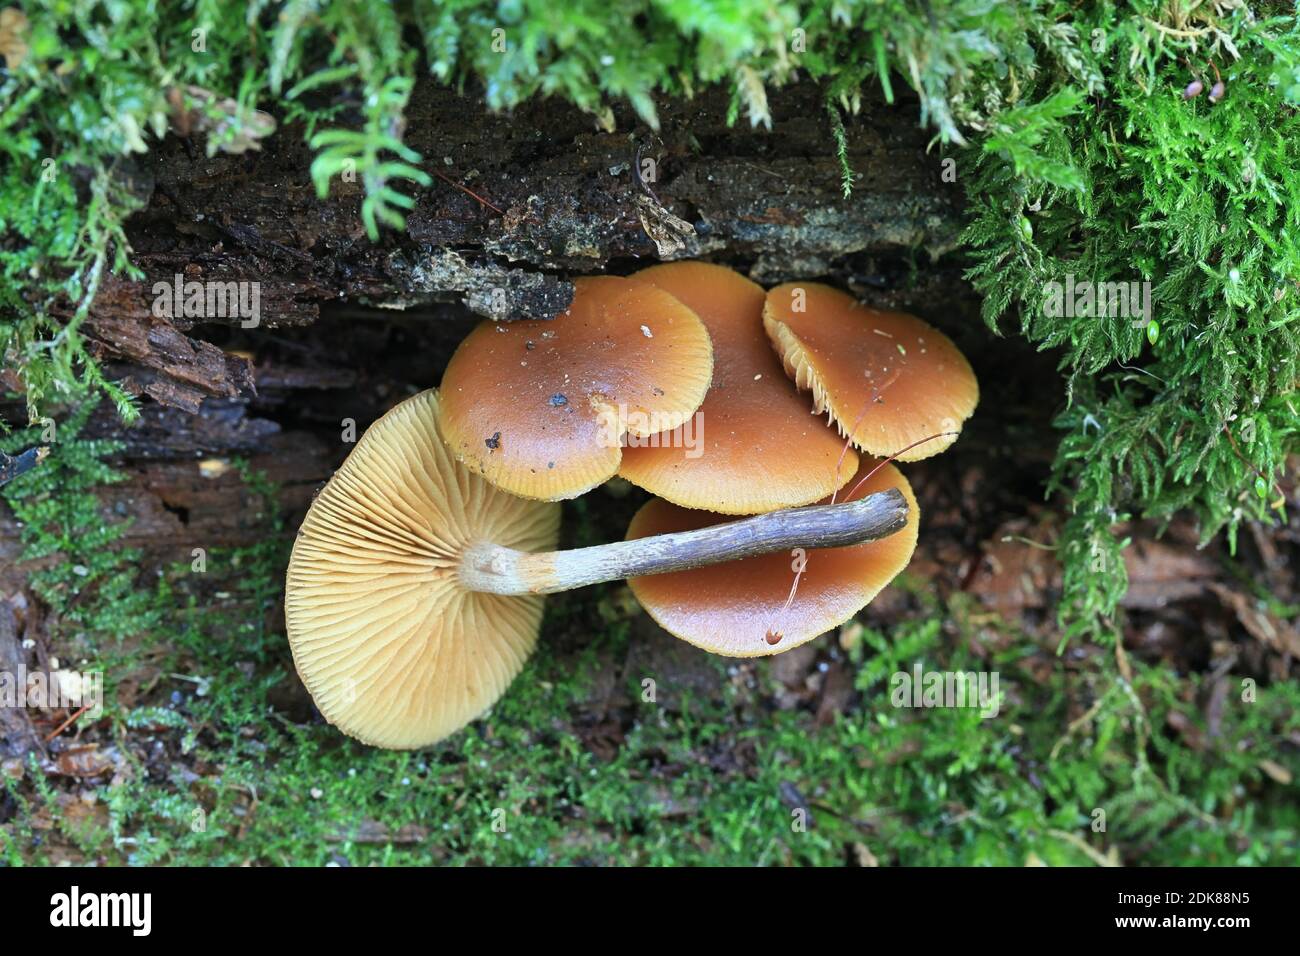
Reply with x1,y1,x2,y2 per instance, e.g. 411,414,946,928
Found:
763,282,979,462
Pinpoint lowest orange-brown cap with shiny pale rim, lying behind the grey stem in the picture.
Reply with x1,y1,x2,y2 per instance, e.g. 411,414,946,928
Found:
628,457,920,657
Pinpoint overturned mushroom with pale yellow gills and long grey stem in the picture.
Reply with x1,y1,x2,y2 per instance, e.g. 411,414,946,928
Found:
285,390,909,748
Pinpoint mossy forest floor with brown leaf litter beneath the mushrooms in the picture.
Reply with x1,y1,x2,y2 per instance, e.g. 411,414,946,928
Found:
0,319,1300,866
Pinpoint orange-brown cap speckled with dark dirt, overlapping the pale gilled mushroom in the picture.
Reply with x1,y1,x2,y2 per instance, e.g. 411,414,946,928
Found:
439,276,712,501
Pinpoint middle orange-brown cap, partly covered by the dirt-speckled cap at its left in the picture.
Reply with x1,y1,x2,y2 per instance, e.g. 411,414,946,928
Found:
619,263,858,515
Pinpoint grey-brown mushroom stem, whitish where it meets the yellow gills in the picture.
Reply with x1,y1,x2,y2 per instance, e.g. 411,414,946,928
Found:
459,489,907,594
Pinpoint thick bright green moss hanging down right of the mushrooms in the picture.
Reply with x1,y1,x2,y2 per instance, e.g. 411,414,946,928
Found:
965,4,1300,642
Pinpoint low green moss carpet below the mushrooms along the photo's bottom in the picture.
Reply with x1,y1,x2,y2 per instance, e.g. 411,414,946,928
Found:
0,590,1300,865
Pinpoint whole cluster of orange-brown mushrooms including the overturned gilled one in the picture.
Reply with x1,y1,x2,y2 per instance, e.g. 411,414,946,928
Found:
285,263,978,749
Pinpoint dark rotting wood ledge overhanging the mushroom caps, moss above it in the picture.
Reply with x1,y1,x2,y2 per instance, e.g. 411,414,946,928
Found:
71,85,959,412
